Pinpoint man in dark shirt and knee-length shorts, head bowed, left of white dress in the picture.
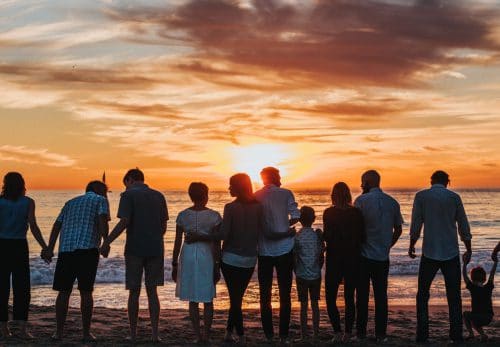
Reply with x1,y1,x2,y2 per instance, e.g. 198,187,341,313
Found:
101,169,168,342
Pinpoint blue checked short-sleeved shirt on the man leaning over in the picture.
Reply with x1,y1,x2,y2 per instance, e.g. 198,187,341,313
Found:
56,192,109,252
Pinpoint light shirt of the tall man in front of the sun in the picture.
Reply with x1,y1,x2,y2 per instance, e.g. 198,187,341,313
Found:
255,184,300,257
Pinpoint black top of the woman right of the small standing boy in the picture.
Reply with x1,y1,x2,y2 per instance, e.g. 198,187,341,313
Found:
323,206,366,258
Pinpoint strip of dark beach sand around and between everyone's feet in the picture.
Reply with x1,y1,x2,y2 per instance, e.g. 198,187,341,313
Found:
0,306,500,346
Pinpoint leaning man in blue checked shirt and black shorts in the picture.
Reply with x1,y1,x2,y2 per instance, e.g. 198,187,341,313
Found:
42,181,110,342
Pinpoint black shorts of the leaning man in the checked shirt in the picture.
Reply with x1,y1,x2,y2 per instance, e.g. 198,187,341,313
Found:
52,248,99,292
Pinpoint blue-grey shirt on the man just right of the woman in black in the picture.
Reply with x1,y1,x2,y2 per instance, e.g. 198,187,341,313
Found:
354,188,403,261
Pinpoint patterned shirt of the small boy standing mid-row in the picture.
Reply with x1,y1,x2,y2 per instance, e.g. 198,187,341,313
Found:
293,227,324,280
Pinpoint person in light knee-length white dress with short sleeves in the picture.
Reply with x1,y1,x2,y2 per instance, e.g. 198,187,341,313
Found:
172,182,222,342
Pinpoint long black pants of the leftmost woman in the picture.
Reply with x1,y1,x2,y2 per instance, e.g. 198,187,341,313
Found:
0,239,31,322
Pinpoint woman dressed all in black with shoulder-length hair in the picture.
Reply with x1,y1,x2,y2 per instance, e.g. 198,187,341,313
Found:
323,182,366,342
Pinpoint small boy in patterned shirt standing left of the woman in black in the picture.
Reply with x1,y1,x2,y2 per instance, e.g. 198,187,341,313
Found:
294,206,324,340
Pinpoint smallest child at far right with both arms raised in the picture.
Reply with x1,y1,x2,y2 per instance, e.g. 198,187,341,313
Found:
462,253,498,341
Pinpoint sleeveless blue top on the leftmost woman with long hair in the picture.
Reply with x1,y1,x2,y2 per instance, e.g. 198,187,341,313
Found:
0,196,31,240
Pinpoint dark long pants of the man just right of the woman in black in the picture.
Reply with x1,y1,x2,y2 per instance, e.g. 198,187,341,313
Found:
356,256,389,337
